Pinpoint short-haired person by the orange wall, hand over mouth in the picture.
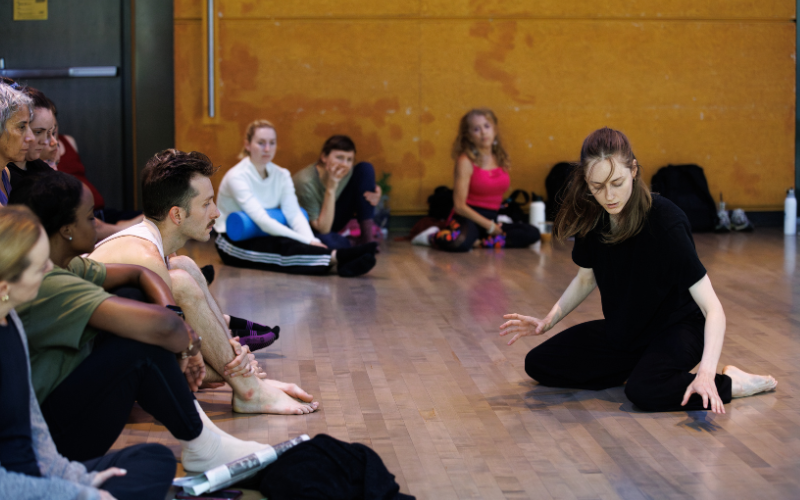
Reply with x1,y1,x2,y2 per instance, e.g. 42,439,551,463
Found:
292,135,382,249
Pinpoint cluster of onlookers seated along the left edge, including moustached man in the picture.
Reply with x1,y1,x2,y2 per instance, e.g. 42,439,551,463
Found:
0,81,318,499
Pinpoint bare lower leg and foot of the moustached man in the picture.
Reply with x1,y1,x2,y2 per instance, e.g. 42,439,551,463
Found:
170,269,319,415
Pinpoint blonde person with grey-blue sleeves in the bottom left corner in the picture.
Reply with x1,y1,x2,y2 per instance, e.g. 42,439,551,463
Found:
0,206,175,500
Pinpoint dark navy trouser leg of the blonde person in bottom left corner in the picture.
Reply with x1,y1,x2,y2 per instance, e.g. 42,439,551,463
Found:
83,444,175,500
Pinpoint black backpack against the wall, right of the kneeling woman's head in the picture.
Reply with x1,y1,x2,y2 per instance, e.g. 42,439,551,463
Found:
651,165,718,233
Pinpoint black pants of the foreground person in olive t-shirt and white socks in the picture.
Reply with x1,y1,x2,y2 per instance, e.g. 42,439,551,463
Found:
42,333,203,461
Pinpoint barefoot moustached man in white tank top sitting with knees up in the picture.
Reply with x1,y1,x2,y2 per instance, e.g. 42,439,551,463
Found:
89,150,319,415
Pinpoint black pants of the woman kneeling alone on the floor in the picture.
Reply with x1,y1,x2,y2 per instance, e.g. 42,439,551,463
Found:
525,314,731,411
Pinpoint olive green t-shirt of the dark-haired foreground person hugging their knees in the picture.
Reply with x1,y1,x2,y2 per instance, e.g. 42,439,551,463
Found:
16,257,113,404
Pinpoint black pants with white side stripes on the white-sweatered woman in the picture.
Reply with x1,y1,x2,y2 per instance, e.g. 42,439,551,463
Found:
216,233,332,276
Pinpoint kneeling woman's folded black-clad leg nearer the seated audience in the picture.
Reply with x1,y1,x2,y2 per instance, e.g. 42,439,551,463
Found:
525,320,639,390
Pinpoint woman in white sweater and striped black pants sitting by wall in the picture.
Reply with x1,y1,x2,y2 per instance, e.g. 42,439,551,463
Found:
215,120,377,277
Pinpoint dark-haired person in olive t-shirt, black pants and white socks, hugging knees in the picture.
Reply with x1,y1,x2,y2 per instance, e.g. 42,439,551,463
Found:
10,172,280,470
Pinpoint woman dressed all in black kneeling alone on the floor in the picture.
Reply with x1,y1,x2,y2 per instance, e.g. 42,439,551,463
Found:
500,128,777,413
